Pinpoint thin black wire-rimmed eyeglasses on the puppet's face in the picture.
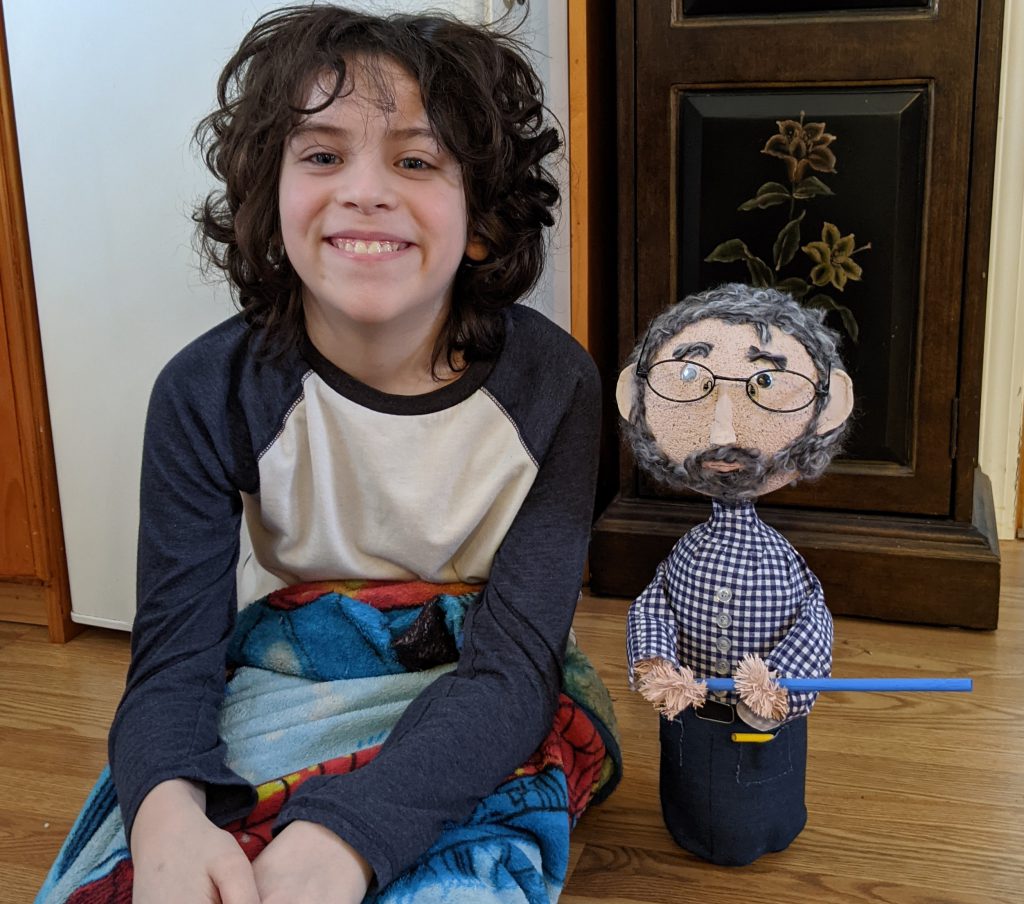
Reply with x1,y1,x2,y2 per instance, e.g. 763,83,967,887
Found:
638,359,828,414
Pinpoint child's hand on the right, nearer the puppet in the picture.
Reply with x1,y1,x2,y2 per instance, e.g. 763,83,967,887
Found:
253,819,373,904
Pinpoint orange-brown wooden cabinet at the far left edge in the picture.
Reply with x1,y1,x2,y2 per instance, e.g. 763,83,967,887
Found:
0,19,78,641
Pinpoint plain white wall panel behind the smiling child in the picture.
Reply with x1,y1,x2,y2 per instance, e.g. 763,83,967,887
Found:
3,0,569,628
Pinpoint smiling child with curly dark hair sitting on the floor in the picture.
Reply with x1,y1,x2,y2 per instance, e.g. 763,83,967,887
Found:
37,6,614,904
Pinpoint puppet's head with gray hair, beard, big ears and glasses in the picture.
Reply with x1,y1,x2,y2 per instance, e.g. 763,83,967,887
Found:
615,283,853,502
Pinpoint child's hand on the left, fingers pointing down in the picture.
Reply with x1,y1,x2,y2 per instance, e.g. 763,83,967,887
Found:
131,779,260,904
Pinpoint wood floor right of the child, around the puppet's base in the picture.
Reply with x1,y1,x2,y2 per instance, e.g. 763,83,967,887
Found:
561,543,1024,904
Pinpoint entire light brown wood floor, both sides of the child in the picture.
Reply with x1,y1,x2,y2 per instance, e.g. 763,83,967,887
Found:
0,543,1024,904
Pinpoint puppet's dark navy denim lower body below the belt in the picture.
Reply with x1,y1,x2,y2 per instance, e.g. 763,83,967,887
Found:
660,709,807,866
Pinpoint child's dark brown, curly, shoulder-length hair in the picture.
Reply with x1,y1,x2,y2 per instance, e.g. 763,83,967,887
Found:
194,5,561,369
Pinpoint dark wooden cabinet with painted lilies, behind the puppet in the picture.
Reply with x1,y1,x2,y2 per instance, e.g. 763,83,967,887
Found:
591,0,1002,628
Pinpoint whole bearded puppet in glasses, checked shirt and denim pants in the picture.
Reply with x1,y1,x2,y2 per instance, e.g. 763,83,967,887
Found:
615,284,853,865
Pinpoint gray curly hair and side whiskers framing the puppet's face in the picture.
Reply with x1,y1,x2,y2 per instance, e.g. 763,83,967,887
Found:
623,283,849,499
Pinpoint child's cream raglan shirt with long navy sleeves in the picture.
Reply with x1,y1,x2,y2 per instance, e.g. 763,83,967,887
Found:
110,306,600,887
